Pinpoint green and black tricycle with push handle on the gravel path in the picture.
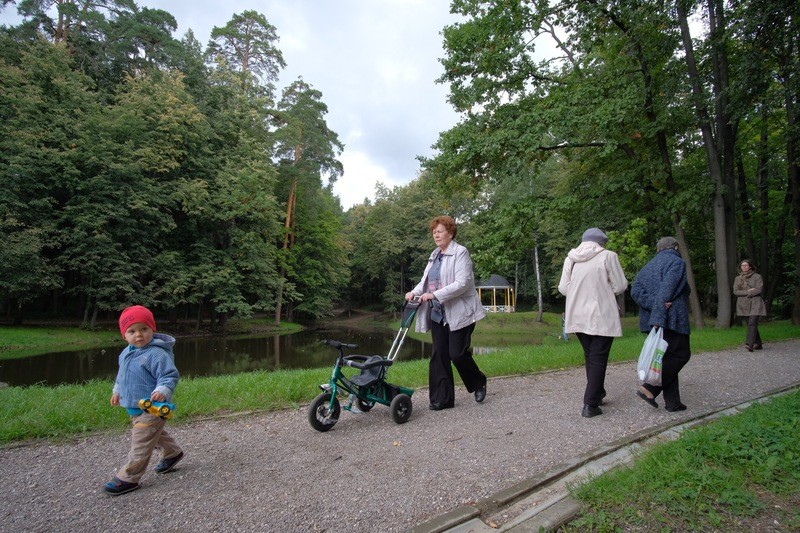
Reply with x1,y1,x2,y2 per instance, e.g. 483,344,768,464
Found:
308,300,419,431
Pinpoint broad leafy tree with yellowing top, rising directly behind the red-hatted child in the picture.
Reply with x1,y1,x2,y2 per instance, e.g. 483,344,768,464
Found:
59,69,203,322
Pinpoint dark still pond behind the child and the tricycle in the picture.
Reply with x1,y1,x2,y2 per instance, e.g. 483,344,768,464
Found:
0,327,431,386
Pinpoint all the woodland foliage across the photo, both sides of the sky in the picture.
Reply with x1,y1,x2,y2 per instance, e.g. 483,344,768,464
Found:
0,0,800,325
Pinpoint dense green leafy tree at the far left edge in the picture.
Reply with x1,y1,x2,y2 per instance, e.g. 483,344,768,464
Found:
0,39,97,321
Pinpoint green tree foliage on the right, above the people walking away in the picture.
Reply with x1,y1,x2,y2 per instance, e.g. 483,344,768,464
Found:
416,0,800,324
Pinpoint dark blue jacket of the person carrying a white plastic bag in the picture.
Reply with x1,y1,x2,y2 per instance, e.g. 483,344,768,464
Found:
631,249,690,335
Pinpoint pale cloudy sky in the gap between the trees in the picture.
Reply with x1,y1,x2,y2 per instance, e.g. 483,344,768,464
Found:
0,0,458,210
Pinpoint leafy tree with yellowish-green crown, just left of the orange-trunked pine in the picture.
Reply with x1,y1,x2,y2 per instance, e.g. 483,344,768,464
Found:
174,62,281,325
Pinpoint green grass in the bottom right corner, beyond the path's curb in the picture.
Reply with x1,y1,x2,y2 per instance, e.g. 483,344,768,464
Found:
563,391,800,532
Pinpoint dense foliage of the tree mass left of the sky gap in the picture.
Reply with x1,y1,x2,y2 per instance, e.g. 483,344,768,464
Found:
0,4,347,326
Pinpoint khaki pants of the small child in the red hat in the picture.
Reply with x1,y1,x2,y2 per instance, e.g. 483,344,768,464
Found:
117,413,182,483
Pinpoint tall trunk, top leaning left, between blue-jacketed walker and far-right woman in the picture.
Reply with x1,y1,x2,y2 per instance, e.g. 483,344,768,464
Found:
676,1,732,328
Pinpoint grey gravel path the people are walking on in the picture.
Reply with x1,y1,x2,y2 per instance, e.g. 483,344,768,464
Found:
0,341,800,532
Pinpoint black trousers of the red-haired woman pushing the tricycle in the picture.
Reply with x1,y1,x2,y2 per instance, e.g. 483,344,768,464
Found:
428,322,486,405
